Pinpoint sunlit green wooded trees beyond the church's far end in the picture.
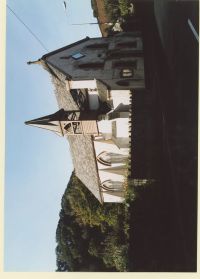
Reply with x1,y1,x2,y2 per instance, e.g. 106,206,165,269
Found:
56,173,129,271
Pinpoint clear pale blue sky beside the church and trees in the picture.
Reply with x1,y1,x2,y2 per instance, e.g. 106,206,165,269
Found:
4,0,101,272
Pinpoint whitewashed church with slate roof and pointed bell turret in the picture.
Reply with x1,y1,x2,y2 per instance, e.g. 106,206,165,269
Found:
26,32,145,203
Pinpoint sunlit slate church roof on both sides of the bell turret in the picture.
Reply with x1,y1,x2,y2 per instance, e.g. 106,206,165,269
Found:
42,62,103,203
